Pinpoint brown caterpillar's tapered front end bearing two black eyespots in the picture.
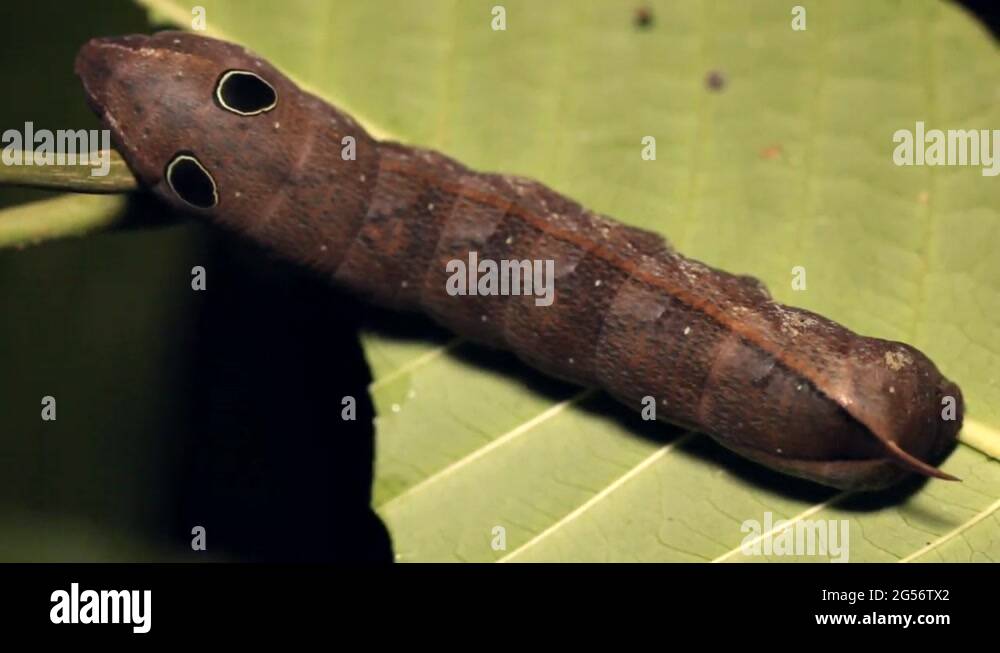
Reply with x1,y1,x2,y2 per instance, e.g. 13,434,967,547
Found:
75,32,374,249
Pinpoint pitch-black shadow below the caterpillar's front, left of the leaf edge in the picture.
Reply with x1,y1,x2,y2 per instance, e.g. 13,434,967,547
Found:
166,233,392,562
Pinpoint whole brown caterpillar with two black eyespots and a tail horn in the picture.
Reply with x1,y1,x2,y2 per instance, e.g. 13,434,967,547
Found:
76,32,963,490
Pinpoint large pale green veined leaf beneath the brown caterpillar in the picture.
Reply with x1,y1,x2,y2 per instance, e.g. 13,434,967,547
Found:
111,0,1000,561
